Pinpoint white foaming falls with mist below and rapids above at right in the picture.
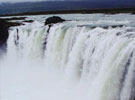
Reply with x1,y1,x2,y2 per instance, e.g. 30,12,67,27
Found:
0,14,135,100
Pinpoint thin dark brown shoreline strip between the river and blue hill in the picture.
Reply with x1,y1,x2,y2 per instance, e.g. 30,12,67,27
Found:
0,7,135,17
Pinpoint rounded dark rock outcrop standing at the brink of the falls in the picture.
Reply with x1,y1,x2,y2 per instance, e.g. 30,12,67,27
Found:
45,16,65,25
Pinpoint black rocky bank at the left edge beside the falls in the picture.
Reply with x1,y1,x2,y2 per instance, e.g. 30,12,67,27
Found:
0,19,23,47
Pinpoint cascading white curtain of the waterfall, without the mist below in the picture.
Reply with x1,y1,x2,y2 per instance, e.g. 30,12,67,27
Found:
0,14,135,100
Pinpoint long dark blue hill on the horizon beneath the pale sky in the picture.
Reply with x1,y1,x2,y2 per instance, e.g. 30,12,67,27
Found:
0,0,135,15
